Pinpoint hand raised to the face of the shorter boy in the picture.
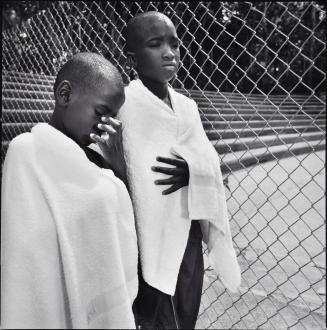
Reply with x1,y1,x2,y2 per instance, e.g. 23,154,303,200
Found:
90,117,127,183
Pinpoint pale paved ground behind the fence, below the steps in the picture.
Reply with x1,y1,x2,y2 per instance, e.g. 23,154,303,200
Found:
197,152,326,330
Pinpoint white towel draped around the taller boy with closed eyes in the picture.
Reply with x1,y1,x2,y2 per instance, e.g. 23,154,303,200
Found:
119,80,241,295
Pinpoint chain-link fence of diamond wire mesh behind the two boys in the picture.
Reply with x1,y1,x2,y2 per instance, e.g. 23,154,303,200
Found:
1,1,326,329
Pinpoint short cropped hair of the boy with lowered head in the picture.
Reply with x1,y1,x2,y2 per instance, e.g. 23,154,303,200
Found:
53,52,124,93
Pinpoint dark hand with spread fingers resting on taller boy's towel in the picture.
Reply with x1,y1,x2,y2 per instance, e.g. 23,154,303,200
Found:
151,157,190,195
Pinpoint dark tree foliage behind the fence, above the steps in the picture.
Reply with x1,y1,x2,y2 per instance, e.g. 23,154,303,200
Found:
2,1,326,93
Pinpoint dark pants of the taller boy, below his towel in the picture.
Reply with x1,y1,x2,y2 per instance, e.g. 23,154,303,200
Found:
133,221,204,329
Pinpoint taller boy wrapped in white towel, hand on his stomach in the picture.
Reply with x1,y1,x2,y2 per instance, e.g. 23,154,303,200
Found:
96,12,241,329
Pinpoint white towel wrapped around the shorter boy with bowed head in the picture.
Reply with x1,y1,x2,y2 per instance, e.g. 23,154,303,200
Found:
1,124,138,329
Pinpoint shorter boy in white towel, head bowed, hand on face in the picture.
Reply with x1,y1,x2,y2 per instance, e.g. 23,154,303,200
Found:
1,53,138,329
